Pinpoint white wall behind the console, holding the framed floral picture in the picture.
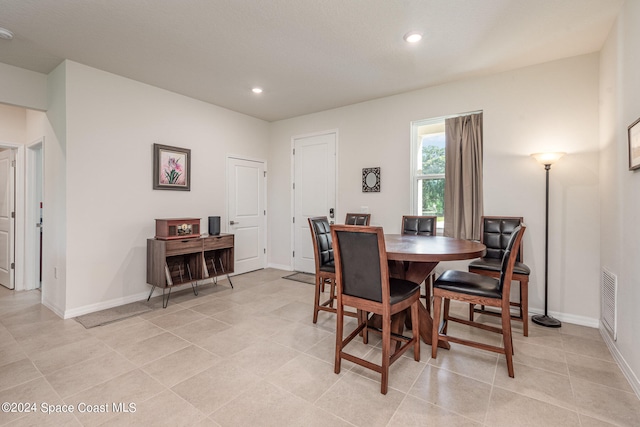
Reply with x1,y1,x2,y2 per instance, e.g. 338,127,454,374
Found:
62,61,268,317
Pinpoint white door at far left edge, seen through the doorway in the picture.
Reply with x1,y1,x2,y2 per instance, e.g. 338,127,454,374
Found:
0,150,15,289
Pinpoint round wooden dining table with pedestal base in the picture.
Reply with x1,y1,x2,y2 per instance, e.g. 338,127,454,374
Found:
384,234,486,348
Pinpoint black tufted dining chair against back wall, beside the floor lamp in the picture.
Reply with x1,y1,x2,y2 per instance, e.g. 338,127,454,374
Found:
469,216,531,337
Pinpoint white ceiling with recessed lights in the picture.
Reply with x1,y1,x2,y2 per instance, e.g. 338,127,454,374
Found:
0,0,623,121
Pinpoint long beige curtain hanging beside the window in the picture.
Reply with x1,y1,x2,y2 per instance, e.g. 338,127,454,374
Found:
444,113,483,240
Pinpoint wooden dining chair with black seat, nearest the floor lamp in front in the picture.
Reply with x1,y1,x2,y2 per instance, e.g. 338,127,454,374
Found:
431,224,526,378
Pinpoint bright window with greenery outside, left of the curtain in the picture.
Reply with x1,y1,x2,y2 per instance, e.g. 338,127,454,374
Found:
411,118,445,228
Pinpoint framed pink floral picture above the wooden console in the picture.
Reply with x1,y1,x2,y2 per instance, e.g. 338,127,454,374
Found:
153,144,191,191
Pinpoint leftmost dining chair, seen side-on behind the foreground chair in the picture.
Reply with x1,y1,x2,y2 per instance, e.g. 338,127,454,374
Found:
308,216,355,323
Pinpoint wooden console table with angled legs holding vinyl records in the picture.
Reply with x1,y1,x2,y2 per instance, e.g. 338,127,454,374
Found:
147,234,233,308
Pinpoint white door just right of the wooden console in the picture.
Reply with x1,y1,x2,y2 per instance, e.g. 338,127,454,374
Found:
227,157,266,273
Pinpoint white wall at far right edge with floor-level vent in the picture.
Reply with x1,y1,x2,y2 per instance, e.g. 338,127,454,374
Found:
599,1,640,395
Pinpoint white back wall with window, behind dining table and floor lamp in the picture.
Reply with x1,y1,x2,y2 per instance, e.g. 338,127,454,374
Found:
268,54,600,326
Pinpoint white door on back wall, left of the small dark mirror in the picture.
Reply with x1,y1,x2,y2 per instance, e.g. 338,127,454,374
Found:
293,132,337,273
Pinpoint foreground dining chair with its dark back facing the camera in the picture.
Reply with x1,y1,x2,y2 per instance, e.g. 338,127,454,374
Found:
331,225,420,394
